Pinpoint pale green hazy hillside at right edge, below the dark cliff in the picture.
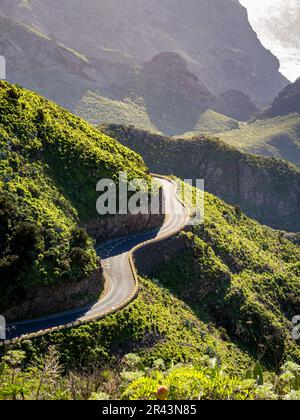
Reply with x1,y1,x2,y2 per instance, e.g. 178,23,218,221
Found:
218,114,300,165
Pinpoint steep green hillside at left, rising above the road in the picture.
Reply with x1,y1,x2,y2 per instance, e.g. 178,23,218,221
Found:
0,82,148,313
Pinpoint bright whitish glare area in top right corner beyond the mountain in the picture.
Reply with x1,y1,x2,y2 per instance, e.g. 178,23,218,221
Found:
240,0,300,81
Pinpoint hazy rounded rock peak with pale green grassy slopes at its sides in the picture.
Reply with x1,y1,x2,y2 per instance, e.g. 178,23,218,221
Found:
75,52,257,136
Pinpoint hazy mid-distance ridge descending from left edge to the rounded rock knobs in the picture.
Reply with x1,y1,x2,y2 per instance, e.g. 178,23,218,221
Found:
0,16,256,135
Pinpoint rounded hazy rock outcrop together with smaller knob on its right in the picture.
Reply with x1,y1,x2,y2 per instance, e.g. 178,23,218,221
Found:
134,52,258,136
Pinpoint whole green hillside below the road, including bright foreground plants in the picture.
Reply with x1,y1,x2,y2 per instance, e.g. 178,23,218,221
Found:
0,180,300,400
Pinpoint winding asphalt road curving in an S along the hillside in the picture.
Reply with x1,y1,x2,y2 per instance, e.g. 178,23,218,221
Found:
7,178,189,339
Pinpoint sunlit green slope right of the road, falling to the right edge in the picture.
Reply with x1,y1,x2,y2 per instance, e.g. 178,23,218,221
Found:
156,180,300,368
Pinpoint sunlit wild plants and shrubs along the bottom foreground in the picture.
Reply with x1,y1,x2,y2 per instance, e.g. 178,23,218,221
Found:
0,347,300,401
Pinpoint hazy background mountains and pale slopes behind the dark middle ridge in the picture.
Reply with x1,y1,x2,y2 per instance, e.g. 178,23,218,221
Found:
0,0,300,159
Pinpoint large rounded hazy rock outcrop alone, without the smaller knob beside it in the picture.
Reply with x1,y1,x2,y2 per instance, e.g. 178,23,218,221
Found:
136,53,214,135
